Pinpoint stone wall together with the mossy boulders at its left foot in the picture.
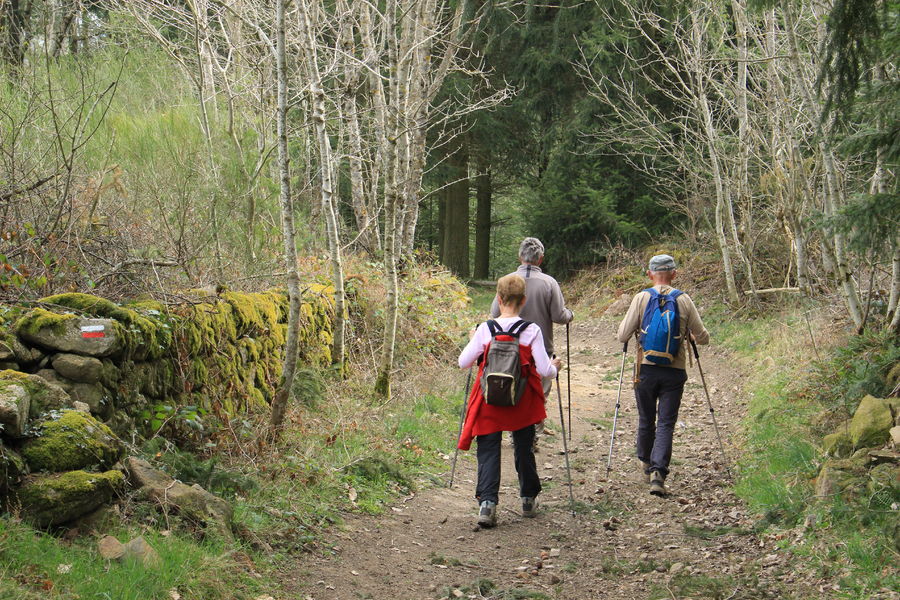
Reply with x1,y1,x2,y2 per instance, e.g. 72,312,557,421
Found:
0,285,334,526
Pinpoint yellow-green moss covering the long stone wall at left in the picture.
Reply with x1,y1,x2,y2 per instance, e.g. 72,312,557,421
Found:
6,283,335,426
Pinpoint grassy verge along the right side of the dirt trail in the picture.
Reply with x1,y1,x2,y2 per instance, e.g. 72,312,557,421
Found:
707,302,900,599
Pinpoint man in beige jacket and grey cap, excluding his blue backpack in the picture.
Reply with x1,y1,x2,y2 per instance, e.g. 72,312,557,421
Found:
617,254,709,496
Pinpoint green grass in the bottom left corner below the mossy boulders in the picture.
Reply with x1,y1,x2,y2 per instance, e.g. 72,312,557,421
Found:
0,517,265,600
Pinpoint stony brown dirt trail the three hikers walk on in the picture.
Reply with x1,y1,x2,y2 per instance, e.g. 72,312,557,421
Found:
287,320,821,600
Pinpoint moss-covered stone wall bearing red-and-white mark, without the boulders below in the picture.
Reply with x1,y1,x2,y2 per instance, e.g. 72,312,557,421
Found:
0,284,334,433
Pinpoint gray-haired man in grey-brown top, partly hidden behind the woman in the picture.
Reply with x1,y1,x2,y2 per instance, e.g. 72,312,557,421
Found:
491,237,575,444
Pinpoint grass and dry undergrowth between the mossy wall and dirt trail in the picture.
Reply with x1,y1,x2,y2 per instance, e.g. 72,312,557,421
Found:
0,261,474,600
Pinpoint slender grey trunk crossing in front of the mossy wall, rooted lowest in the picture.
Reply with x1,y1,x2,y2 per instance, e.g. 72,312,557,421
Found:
269,0,300,440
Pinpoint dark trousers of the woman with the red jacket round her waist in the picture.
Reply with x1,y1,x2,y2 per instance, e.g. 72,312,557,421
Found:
475,425,541,502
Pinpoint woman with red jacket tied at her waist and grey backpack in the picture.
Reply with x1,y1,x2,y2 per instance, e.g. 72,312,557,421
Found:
458,274,562,527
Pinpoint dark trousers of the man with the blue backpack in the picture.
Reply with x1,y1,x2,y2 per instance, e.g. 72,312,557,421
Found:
634,365,687,477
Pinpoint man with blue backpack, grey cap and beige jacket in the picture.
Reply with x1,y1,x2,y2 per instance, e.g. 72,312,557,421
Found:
617,254,709,496
